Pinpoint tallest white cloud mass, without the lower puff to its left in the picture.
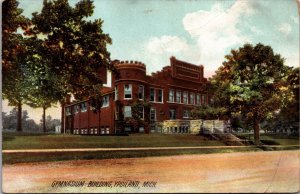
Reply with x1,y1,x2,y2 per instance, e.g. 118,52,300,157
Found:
183,1,255,71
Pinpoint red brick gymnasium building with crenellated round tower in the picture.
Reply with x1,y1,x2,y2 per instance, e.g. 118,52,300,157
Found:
63,57,209,135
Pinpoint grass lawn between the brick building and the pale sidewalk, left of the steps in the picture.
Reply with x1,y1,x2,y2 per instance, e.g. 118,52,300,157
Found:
2,133,224,150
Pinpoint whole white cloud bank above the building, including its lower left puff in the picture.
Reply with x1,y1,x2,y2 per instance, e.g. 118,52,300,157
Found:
145,1,258,76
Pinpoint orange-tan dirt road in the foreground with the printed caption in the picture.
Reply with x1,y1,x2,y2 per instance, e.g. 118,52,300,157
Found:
3,150,300,193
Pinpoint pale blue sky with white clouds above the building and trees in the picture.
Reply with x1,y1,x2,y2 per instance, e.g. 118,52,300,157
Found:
3,0,300,122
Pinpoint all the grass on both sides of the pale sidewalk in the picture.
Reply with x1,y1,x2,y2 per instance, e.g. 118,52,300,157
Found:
2,133,299,164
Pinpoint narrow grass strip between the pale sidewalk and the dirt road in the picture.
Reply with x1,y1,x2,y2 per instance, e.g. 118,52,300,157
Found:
3,147,262,164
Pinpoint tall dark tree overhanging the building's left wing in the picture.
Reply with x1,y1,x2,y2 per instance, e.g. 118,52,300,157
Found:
27,0,114,130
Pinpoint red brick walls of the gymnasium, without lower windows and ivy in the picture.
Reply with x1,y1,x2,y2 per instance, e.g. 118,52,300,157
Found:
66,58,209,133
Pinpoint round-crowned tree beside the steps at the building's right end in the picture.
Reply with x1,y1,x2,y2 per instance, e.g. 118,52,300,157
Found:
211,44,292,144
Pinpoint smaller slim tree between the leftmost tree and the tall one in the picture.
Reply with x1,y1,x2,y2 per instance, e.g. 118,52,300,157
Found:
26,38,64,132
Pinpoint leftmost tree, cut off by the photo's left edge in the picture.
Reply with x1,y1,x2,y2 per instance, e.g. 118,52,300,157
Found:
2,0,29,131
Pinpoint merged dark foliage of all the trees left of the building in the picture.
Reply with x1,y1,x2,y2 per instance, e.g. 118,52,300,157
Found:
2,0,115,130
